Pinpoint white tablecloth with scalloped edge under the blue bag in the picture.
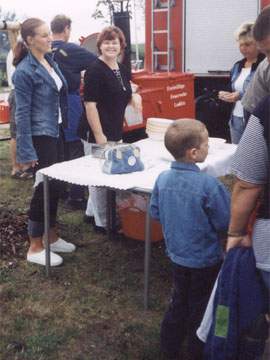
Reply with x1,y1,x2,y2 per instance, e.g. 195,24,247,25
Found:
37,139,236,191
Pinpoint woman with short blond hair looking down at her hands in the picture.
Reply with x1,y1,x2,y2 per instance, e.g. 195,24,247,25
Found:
219,23,264,144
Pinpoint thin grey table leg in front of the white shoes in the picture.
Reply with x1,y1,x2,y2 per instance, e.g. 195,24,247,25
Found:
43,175,51,276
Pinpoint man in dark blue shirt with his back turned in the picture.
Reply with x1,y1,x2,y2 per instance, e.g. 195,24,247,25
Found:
51,15,96,207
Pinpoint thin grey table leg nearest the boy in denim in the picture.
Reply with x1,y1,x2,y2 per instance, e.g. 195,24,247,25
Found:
143,196,151,310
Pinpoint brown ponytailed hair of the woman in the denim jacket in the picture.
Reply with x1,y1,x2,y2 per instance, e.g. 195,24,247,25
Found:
13,18,45,66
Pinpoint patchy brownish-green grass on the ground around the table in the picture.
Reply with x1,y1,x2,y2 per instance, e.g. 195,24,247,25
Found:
0,136,236,360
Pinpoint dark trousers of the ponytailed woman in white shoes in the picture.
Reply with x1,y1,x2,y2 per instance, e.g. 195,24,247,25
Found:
28,130,64,237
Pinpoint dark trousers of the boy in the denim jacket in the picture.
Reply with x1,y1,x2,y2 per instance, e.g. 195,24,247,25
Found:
161,264,221,360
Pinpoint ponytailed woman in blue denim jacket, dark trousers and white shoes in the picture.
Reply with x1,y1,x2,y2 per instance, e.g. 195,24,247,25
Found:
12,18,75,266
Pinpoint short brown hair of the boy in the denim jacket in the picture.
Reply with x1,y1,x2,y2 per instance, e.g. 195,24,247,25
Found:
164,119,206,160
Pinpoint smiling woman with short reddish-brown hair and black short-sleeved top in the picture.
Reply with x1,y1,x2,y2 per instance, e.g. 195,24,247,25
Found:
79,26,140,232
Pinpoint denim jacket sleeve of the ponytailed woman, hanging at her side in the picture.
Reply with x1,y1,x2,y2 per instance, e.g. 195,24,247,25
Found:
13,71,38,163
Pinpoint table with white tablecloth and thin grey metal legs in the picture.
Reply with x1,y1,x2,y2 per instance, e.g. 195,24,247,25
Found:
36,139,237,309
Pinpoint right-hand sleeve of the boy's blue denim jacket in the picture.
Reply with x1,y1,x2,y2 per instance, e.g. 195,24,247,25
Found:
207,183,230,232
